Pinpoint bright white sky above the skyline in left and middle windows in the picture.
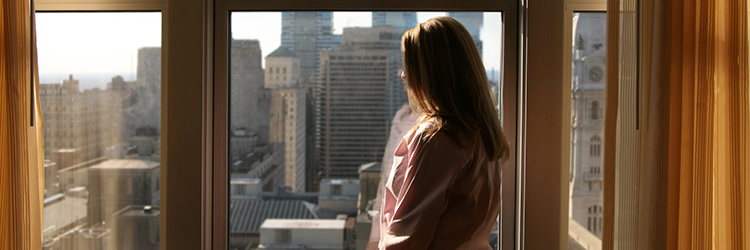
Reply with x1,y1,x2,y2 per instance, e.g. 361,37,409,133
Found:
36,12,501,88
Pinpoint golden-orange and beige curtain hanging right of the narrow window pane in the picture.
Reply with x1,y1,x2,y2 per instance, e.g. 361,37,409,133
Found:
603,0,750,249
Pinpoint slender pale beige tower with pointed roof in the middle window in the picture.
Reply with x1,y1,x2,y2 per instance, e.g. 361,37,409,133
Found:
265,47,307,192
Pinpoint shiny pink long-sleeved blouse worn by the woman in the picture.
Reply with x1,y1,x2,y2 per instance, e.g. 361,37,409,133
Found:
379,122,501,249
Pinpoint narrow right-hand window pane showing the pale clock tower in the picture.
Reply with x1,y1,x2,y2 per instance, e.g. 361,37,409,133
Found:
568,12,607,249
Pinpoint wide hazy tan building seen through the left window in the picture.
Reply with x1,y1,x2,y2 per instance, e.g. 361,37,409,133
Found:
39,75,132,164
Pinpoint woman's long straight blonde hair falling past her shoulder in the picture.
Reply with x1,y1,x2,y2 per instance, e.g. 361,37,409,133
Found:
401,17,509,161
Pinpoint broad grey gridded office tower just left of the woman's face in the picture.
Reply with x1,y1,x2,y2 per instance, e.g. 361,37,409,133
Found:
315,27,406,178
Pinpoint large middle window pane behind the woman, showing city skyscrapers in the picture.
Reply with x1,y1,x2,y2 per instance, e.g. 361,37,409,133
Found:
228,12,502,249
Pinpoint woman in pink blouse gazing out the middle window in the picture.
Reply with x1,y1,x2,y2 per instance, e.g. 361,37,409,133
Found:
379,17,508,249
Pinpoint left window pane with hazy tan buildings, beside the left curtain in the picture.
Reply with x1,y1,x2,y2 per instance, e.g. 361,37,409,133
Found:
36,12,161,250
